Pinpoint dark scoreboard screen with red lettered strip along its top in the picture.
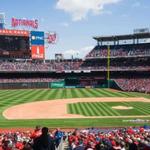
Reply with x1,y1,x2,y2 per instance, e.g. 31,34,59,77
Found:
0,29,31,58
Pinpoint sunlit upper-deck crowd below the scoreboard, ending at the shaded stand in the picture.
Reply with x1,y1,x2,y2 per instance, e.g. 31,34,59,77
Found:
0,60,82,71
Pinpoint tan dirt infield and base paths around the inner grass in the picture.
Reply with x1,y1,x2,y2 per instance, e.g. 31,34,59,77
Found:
3,97,149,119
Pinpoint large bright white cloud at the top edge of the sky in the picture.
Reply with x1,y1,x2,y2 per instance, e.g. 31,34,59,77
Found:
56,0,121,21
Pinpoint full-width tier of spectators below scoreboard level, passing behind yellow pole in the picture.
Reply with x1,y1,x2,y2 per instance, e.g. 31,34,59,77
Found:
0,59,150,72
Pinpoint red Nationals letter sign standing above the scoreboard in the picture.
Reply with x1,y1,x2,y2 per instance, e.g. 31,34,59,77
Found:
11,18,38,29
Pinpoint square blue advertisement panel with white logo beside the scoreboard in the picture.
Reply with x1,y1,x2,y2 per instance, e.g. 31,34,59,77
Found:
31,31,44,45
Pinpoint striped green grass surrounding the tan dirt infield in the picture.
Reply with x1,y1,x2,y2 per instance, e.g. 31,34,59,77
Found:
0,89,150,128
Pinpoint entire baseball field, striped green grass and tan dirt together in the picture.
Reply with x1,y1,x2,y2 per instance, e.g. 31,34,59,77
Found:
0,88,150,128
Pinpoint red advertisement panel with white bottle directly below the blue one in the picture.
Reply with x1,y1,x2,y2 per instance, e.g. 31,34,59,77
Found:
31,45,45,59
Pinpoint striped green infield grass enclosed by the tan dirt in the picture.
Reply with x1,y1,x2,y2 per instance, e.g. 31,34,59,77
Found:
68,102,150,116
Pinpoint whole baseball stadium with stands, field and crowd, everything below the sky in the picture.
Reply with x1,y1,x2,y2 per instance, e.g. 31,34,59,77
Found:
0,0,150,150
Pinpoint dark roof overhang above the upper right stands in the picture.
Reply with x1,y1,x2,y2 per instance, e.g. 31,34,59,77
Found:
93,32,150,42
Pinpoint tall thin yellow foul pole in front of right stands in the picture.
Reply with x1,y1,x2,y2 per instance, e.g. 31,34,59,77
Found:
107,44,110,88
